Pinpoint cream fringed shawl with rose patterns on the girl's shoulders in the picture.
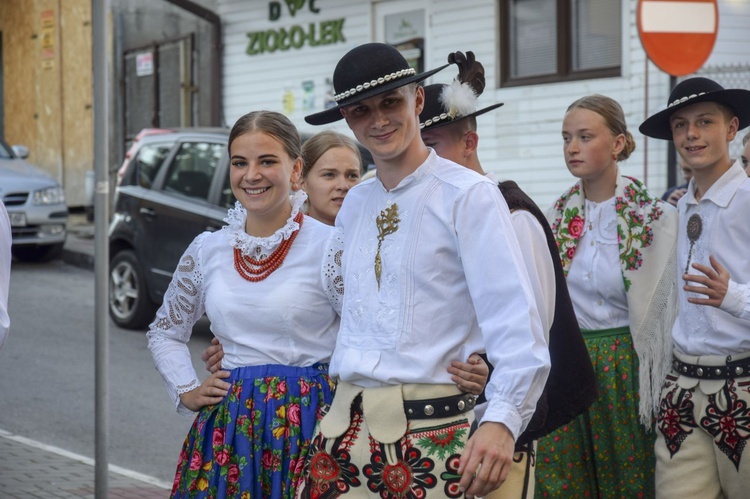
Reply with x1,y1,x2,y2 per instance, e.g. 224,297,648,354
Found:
547,174,677,428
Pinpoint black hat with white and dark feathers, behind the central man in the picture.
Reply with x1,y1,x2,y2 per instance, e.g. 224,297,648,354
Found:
419,51,503,131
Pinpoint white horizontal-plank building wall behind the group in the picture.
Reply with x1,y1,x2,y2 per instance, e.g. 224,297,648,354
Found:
217,0,750,208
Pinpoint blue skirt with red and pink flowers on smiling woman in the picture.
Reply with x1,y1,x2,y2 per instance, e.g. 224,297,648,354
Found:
172,364,334,499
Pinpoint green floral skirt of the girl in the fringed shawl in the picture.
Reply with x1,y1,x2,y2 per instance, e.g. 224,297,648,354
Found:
536,327,656,499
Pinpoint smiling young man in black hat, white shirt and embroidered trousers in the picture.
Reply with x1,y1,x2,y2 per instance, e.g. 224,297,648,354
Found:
302,43,549,498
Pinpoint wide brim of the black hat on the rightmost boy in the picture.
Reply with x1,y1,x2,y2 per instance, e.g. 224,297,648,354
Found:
638,88,750,140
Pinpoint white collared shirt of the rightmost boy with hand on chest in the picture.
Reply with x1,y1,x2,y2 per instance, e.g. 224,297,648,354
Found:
672,161,750,355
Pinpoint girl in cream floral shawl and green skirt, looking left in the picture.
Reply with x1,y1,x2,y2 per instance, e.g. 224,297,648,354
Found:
536,95,677,498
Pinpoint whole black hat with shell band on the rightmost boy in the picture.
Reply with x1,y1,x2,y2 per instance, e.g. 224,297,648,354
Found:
638,77,750,140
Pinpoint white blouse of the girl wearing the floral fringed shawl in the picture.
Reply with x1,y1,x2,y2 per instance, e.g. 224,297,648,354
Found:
567,197,630,331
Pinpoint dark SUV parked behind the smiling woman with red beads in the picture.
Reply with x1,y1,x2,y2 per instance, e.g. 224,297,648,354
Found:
109,128,372,329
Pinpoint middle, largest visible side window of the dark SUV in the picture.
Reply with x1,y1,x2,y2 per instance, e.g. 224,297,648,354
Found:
164,142,226,200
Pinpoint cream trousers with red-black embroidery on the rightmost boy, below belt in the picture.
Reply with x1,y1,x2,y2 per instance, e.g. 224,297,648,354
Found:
655,372,750,498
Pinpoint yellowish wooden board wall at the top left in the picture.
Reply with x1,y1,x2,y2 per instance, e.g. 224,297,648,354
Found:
0,0,93,205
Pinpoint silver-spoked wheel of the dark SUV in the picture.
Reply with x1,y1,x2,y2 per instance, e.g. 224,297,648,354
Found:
109,250,156,329
